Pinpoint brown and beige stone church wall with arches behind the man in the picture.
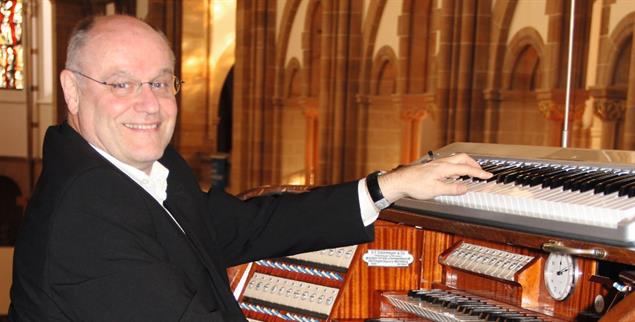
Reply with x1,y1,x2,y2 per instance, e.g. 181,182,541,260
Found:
6,0,635,192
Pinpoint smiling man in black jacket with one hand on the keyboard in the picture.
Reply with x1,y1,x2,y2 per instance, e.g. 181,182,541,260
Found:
9,16,489,322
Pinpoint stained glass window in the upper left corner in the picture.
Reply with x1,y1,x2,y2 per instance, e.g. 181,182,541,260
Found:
0,0,24,89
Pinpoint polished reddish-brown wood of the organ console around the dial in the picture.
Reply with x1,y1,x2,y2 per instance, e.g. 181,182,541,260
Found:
232,187,635,321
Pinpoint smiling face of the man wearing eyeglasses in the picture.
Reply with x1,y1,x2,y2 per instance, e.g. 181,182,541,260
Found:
60,16,177,173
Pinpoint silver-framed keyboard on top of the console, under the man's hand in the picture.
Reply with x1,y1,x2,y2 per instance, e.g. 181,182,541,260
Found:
395,143,635,246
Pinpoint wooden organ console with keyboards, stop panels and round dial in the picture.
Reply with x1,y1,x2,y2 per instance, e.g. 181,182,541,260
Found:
232,143,635,322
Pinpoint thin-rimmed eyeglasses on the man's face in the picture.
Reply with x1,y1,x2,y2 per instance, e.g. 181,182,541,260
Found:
69,69,185,97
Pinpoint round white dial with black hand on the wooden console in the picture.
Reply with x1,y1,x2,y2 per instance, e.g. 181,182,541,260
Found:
544,253,576,301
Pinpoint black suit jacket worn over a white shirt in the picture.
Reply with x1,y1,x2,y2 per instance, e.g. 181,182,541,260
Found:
9,123,373,322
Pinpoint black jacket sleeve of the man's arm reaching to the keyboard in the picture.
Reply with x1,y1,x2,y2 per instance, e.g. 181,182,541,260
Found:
208,182,374,265
